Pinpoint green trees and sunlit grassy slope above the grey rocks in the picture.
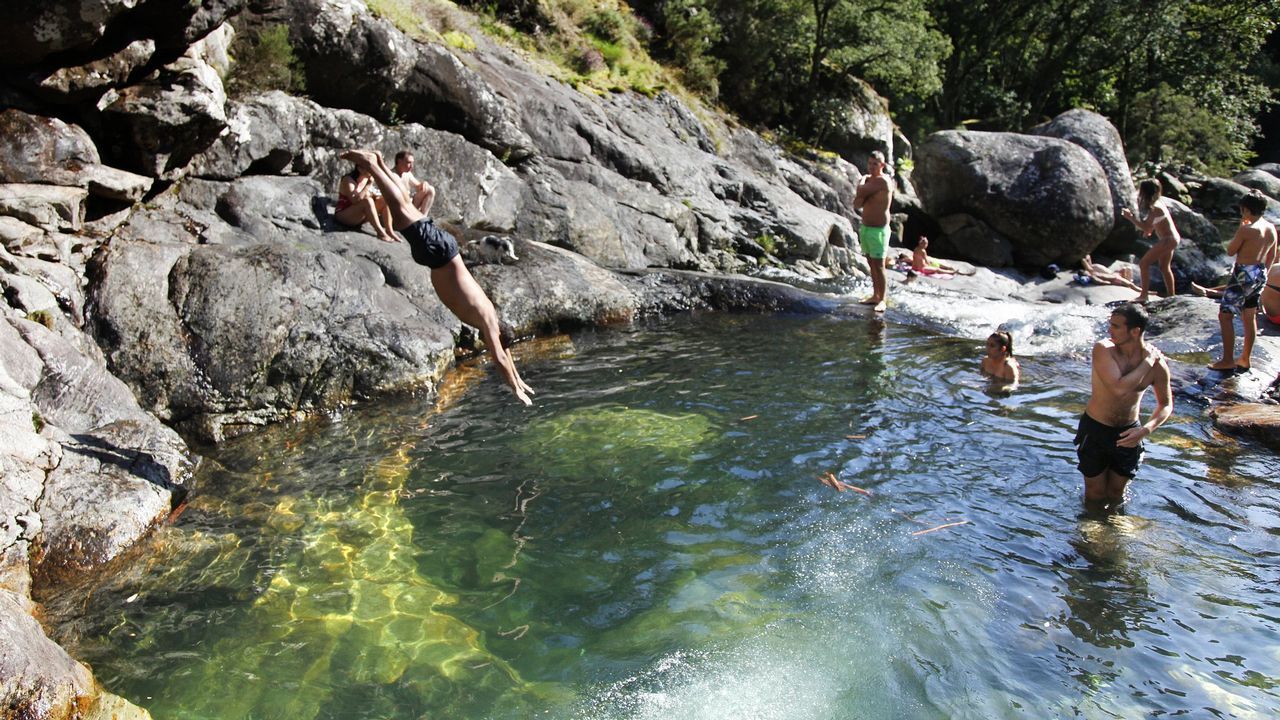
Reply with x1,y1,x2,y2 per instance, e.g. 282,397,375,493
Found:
237,0,1280,174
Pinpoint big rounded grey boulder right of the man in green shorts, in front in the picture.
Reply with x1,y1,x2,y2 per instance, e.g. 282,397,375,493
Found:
913,131,1115,266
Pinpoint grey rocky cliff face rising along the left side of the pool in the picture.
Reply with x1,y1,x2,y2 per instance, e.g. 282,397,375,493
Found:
0,0,875,717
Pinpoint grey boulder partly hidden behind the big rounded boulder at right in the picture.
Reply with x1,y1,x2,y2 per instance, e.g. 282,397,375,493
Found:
1030,109,1138,255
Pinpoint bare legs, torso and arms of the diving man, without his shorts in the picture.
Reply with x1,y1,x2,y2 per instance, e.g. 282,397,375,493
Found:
342,150,534,405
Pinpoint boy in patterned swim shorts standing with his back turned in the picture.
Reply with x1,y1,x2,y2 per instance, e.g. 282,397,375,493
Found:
1208,191,1276,373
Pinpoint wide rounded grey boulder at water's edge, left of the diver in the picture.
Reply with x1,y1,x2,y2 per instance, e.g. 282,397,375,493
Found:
90,233,458,441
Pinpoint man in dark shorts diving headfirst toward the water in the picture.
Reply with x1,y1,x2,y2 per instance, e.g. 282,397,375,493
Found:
342,150,534,405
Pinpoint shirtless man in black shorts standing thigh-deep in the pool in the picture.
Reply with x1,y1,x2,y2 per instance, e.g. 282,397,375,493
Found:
1075,304,1174,507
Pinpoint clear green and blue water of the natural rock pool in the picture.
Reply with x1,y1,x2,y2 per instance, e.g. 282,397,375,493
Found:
55,316,1280,720
